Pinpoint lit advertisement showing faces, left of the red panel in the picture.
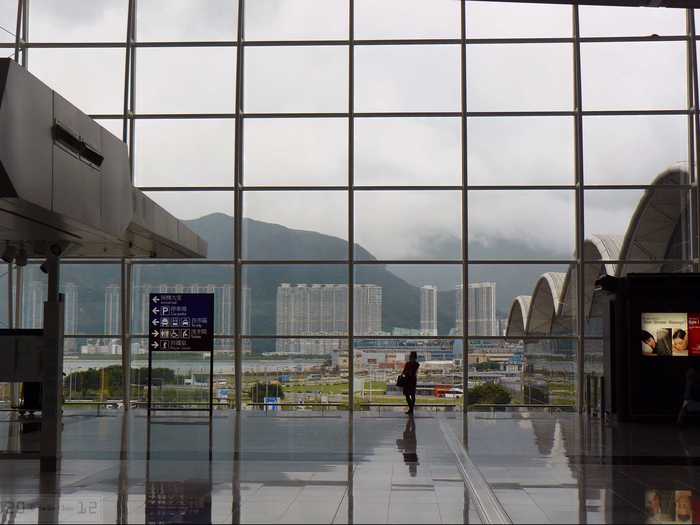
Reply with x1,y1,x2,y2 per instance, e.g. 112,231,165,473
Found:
641,313,688,357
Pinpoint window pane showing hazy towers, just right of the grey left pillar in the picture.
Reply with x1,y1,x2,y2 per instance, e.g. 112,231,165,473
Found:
61,264,121,337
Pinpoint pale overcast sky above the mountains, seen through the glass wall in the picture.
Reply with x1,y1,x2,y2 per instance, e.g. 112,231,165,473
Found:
0,0,687,258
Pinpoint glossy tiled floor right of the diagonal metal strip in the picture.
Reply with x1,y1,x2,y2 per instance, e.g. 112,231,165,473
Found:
451,412,700,523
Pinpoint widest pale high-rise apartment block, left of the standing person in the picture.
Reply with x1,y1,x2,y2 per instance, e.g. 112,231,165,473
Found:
276,283,382,353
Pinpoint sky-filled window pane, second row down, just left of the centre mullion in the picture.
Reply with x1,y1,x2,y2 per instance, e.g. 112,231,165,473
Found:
245,46,348,113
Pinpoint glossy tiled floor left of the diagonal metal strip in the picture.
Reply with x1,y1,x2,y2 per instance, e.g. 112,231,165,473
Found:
0,411,478,523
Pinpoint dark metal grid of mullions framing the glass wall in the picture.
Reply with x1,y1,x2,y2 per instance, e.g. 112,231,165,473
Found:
9,0,700,410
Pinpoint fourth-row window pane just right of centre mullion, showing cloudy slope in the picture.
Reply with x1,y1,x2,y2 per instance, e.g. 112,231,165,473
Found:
355,191,462,261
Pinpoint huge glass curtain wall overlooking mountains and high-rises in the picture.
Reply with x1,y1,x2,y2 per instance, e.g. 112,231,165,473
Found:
0,0,700,406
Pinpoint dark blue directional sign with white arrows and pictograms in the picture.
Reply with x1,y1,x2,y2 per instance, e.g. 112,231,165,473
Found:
148,293,214,352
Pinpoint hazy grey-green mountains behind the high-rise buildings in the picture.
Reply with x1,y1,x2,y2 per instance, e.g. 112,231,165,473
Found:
19,213,559,346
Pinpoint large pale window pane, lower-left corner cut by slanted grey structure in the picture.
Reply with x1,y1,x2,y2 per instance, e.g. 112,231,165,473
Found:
29,49,125,114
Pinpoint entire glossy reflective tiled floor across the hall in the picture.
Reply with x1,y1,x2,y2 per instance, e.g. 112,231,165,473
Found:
0,410,700,523
